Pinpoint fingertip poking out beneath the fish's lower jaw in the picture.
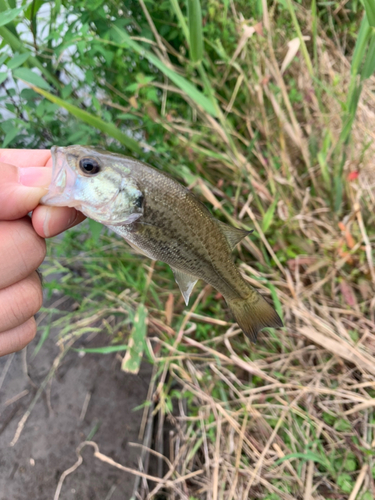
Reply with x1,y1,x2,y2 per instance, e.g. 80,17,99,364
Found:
32,205,86,238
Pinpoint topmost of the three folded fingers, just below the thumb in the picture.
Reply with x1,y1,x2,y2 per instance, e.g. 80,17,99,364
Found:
0,217,46,289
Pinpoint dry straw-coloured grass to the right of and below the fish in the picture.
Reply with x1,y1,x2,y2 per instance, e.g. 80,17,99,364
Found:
9,2,375,500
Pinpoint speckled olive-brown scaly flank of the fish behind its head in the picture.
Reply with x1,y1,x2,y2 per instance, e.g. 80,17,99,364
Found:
113,165,249,298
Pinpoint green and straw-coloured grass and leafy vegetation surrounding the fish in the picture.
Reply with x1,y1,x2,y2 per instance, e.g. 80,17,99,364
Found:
0,0,375,500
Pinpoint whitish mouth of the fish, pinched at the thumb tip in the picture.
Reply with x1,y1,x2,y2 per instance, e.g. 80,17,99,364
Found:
40,146,77,207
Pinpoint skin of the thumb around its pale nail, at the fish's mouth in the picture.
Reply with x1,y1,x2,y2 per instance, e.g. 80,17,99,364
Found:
0,163,52,220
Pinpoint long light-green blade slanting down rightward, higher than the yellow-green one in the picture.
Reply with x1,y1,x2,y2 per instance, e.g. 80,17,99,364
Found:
108,25,217,116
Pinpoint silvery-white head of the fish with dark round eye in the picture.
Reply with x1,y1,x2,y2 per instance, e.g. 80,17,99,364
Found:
41,146,144,225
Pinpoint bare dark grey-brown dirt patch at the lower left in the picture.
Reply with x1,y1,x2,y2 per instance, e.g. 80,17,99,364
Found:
0,294,151,500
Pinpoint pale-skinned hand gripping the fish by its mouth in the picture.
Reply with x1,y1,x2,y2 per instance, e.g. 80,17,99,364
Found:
0,149,85,356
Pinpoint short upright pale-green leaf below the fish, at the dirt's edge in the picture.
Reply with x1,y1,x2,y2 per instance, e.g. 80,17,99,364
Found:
121,304,147,374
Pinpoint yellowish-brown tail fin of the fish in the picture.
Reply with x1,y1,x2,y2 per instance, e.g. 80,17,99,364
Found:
227,290,284,342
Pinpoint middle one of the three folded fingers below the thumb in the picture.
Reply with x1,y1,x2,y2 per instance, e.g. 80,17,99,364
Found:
0,271,43,332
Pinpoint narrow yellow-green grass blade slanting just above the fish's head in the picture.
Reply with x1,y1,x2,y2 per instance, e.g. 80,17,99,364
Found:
21,83,142,154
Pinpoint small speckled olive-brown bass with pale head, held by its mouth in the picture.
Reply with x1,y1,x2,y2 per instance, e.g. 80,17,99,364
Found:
41,146,283,342
